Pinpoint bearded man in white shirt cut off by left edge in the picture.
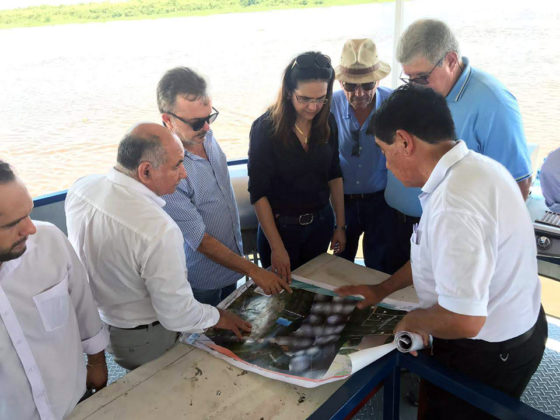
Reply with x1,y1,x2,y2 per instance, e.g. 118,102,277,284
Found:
0,161,108,420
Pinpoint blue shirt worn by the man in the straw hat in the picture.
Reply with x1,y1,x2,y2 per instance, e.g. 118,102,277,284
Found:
331,87,392,194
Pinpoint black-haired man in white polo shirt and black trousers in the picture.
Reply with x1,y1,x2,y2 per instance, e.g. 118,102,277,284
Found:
338,85,547,419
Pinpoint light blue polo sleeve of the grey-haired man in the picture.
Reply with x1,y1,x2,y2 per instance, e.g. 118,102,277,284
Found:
476,91,531,182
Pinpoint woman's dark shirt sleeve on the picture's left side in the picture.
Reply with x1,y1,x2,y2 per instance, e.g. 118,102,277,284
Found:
247,117,274,204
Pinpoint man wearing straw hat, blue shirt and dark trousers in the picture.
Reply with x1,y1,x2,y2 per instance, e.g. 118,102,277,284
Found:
331,39,399,272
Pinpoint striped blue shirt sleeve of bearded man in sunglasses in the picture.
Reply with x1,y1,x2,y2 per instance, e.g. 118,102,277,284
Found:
163,180,206,251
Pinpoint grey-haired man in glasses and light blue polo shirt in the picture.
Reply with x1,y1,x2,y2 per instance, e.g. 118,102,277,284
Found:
385,19,531,270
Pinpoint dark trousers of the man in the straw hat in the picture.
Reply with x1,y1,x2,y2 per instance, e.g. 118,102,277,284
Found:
339,191,394,273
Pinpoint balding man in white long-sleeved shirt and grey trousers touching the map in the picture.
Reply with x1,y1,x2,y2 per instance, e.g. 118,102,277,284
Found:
66,123,251,369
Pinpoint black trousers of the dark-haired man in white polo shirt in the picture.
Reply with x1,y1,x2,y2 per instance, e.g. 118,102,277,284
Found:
418,307,548,420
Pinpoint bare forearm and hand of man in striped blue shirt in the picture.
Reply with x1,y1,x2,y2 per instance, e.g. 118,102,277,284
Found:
197,233,292,294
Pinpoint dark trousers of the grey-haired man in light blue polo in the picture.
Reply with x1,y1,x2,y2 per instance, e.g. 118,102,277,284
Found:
385,208,420,274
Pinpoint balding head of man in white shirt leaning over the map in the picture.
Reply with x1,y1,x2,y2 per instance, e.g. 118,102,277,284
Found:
117,123,186,195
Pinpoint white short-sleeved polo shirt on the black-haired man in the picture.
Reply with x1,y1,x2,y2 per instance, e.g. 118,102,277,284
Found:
410,141,541,342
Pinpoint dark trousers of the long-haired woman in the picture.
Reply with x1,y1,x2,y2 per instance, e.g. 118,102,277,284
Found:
257,205,334,270
